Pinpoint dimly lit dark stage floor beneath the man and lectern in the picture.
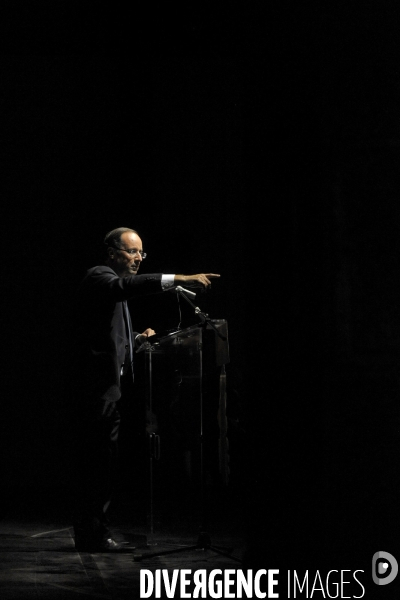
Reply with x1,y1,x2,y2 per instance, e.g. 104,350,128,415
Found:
0,494,246,600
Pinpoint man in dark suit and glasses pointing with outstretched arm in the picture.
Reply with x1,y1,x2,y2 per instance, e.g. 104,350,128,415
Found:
70,227,219,552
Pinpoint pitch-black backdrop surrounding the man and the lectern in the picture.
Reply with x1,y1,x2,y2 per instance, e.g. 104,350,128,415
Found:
1,2,400,597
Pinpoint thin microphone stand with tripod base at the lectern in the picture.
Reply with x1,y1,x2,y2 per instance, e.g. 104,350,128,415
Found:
134,285,242,563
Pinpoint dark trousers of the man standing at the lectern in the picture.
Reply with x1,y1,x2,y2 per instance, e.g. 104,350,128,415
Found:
74,399,120,543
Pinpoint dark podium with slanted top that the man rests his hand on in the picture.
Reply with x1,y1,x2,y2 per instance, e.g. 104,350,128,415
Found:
140,319,229,547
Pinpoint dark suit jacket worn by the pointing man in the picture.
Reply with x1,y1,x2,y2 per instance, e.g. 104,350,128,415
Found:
76,265,162,401
